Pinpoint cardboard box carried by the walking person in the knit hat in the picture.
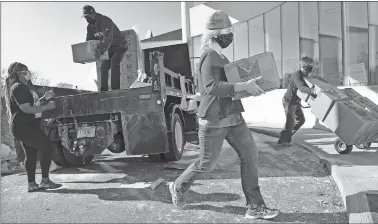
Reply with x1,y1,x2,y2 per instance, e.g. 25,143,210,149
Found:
224,52,281,100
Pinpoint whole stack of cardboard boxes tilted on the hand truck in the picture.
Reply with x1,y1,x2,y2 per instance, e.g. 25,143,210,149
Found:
297,77,378,145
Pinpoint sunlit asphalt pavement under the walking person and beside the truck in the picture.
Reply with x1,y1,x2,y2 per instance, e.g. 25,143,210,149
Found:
1,133,348,223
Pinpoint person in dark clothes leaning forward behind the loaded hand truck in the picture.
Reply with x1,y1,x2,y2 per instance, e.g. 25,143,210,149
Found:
278,57,316,146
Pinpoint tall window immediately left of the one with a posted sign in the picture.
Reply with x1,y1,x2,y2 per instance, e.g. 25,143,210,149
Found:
318,2,343,86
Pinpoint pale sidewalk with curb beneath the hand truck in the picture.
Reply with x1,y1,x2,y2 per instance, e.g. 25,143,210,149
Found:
249,123,378,223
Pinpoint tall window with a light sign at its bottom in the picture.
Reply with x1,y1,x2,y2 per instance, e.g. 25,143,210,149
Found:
344,2,369,86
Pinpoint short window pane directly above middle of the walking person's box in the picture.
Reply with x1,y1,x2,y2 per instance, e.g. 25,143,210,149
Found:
248,16,265,56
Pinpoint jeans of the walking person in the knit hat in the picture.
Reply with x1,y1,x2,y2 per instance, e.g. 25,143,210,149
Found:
175,119,265,206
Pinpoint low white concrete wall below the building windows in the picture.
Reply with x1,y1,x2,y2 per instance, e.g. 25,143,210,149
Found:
242,86,378,129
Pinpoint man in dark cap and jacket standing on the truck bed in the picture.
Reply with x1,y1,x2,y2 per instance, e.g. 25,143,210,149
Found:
83,5,128,91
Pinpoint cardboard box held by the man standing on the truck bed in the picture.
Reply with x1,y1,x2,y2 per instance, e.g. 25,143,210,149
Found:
72,40,109,63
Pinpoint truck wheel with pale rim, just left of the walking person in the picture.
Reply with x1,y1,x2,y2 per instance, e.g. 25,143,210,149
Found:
163,113,185,161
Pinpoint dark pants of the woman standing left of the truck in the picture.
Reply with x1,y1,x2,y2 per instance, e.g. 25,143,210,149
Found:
11,120,52,183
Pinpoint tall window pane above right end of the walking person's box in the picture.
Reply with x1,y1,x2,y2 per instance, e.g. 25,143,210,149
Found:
264,7,282,79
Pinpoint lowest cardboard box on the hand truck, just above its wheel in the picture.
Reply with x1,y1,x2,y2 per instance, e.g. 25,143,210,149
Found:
323,100,378,145
